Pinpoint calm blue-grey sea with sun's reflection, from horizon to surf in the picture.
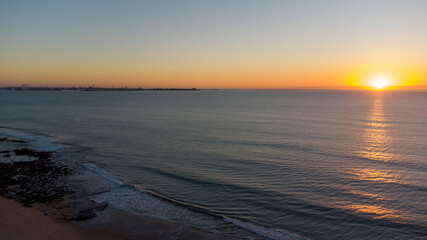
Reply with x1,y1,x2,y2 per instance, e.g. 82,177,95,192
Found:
0,90,427,239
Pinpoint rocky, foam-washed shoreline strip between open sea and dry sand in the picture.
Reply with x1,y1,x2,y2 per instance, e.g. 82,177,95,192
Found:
0,131,304,240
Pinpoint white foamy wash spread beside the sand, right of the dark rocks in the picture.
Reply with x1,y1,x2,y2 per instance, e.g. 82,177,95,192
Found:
91,179,305,240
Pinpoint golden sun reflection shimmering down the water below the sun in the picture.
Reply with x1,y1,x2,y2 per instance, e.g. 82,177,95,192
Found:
341,94,405,222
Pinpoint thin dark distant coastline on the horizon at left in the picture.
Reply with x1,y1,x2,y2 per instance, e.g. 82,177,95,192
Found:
0,86,200,91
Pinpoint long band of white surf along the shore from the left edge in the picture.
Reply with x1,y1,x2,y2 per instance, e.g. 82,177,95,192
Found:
0,127,303,240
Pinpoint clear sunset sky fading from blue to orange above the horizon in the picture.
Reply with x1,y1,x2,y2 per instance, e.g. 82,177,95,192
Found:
0,0,427,89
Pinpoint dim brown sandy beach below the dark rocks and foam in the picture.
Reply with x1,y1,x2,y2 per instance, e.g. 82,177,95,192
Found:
0,197,231,240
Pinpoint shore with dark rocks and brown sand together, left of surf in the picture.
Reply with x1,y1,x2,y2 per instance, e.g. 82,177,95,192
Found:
0,137,241,240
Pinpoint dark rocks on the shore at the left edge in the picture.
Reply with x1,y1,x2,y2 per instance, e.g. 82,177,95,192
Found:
0,147,108,221
